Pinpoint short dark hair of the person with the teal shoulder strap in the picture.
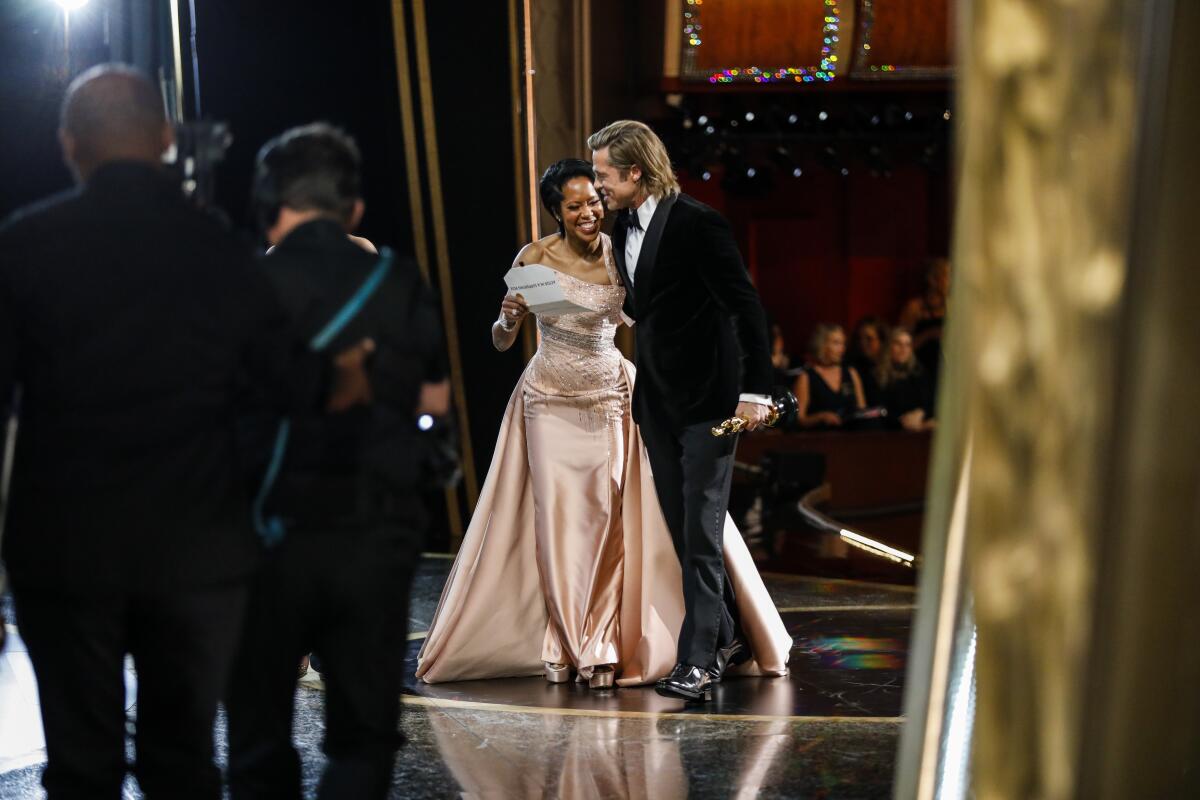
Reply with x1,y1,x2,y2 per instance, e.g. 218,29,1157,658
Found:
253,122,362,228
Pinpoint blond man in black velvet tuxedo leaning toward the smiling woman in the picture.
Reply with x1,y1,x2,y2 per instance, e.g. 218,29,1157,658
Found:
588,120,772,700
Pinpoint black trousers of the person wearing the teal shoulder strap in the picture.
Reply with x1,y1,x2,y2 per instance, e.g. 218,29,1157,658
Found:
226,527,418,800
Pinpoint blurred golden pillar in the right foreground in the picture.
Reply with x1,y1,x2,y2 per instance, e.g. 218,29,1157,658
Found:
896,0,1200,800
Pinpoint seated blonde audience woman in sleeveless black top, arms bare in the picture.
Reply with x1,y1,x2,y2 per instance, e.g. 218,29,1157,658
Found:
796,325,866,429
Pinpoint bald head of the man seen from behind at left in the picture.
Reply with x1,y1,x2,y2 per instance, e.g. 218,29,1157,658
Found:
59,64,173,181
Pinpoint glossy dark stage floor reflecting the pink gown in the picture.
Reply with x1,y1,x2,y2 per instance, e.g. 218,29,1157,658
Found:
0,557,913,800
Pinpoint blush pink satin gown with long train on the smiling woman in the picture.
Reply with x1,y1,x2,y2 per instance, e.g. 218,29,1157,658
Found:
416,232,792,686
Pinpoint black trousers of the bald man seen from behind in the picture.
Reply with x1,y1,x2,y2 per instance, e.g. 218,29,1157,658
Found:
13,583,246,800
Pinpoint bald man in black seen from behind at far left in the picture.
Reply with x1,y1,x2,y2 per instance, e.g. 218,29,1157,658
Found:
0,65,365,800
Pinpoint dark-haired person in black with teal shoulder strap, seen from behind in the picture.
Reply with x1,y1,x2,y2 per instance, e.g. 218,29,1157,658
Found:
227,124,449,800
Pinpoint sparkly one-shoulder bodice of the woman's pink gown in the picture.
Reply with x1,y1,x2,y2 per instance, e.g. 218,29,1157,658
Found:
526,241,625,395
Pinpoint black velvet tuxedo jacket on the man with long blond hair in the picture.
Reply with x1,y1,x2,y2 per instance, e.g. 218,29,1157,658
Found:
613,194,772,426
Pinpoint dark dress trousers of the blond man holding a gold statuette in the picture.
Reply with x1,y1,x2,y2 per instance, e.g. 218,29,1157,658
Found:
640,415,740,668
